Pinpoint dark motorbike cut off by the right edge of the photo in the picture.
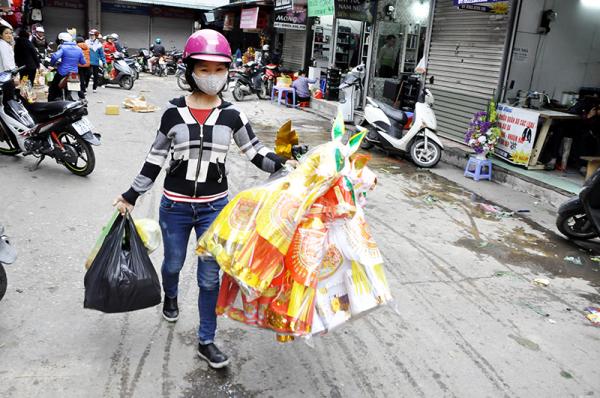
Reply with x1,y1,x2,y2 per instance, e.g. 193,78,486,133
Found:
556,169,600,240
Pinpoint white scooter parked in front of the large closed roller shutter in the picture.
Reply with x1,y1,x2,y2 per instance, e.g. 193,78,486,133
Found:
361,88,444,168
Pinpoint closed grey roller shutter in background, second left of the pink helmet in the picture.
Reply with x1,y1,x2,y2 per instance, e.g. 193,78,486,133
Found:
102,12,150,51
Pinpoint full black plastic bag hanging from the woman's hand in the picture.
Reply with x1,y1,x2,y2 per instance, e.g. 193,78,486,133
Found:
83,214,161,313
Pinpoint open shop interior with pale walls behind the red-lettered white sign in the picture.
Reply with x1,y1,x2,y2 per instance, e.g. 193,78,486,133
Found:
504,0,600,192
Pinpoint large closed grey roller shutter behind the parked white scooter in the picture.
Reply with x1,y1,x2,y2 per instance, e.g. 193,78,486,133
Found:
427,0,509,142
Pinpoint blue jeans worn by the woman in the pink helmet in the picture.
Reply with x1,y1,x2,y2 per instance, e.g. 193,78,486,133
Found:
159,196,228,344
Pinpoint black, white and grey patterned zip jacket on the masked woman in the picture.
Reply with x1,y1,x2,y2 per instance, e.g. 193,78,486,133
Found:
123,97,285,204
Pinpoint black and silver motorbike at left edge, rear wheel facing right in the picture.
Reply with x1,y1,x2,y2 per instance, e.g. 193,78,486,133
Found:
0,67,100,176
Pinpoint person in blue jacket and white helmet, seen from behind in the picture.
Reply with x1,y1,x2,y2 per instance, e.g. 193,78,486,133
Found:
48,32,86,101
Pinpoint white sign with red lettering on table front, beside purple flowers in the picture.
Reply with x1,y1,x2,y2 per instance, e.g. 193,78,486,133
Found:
494,104,540,166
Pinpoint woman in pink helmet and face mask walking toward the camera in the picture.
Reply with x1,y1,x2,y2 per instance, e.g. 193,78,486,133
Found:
114,29,295,368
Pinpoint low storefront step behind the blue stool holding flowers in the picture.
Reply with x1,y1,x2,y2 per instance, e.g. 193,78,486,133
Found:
442,138,581,207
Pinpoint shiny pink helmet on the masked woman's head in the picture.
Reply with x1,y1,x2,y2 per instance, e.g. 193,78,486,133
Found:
183,29,231,62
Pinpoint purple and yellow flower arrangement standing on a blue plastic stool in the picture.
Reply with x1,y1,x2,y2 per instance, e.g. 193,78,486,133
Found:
465,100,500,159
